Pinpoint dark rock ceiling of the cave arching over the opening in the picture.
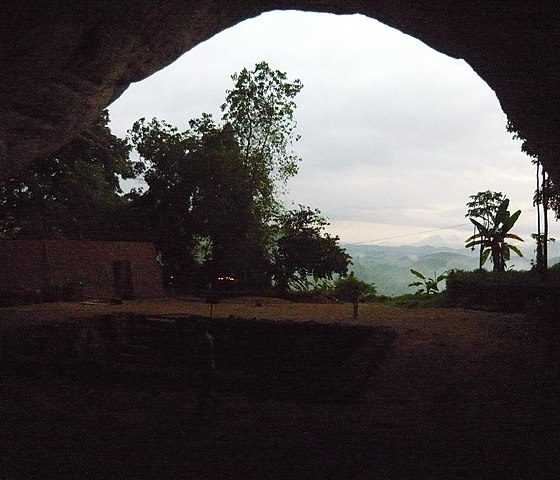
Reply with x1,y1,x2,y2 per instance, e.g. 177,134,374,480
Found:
0,0,560,183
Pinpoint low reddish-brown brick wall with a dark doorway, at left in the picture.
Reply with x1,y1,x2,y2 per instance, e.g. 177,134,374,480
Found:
0,239,163,298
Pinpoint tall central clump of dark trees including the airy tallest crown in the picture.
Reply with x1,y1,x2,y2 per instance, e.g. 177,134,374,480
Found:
130,62,302,284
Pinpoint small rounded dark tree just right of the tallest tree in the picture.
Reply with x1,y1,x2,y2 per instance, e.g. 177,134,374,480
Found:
274,205,350,291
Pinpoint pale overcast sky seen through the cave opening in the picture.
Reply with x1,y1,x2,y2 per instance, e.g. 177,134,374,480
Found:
110,12,557,253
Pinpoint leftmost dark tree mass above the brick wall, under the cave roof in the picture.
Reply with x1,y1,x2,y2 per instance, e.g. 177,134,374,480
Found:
0,111,137,239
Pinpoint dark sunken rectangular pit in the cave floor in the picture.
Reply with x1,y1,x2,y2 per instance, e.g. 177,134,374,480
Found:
1,315,396,403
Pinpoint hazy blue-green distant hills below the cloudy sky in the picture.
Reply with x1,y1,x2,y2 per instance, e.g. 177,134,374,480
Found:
342,244,560,296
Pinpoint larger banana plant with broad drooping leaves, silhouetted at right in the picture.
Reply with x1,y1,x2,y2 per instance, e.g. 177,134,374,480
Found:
465,199,523,272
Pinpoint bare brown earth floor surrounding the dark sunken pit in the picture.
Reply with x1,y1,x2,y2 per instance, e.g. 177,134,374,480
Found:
0,298,560,479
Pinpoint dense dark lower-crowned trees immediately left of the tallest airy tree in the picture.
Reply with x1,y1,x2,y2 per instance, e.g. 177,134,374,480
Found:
130,114,274,283
